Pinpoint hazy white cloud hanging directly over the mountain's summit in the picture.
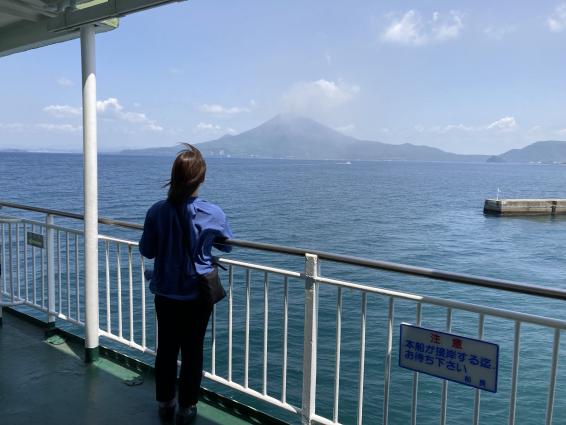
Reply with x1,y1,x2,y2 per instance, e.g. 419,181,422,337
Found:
283,79,360,114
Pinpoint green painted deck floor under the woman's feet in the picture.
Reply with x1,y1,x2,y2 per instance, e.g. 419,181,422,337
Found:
0,314,255,425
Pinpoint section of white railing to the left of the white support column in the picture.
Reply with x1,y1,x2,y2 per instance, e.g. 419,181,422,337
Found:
0,215,84,326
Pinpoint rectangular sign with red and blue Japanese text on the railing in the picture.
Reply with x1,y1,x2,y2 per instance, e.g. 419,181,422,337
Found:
399,323,499,392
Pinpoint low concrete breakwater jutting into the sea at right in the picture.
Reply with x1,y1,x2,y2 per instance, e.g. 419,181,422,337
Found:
483,199,566,215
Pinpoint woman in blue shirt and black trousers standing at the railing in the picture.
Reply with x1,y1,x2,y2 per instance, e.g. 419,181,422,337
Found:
139,144,232,424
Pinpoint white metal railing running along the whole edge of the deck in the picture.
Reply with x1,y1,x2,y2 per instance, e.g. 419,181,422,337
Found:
0,203,566,425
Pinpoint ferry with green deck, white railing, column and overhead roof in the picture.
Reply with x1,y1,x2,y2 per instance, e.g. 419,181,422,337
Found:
0,0,566,424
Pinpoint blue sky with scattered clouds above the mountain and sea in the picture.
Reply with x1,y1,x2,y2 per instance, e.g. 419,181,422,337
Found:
0,0,566,154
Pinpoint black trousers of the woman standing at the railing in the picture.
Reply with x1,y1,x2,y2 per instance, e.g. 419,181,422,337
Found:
155,295,212,407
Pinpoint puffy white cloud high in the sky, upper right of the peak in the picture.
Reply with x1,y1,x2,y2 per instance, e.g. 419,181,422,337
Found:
381,9,464,46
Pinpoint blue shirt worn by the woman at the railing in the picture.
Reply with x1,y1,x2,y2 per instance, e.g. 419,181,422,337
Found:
139,198,232,300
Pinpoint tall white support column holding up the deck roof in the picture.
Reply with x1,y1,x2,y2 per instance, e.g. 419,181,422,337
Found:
81,25,98,363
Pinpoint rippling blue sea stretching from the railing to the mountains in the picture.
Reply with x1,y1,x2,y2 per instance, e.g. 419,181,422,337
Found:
0,153,566,425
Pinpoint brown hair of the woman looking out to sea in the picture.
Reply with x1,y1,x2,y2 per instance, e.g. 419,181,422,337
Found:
165,143,206,204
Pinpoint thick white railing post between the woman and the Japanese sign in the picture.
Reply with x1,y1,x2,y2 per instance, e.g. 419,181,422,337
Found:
301,254,318,425
